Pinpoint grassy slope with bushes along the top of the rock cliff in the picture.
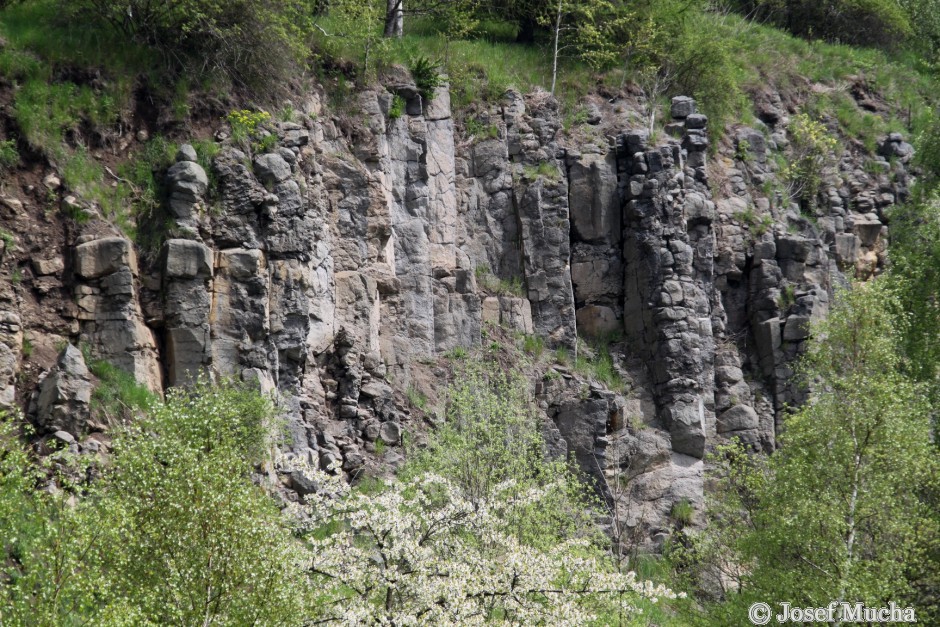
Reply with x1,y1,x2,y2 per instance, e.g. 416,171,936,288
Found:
0,0,937,159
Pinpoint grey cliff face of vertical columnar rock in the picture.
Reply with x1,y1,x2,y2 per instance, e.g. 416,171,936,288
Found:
0,74,911,546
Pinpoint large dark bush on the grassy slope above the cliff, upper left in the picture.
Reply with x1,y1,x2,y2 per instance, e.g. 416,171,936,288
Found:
62,0,315,87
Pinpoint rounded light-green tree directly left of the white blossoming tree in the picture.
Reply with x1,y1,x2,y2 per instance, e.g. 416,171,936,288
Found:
99,382,304,625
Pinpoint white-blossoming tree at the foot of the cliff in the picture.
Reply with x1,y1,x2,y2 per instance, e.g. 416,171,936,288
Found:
294,464,677,625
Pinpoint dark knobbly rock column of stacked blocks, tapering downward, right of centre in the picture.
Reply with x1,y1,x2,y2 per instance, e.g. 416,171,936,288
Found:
621,103,714,458
